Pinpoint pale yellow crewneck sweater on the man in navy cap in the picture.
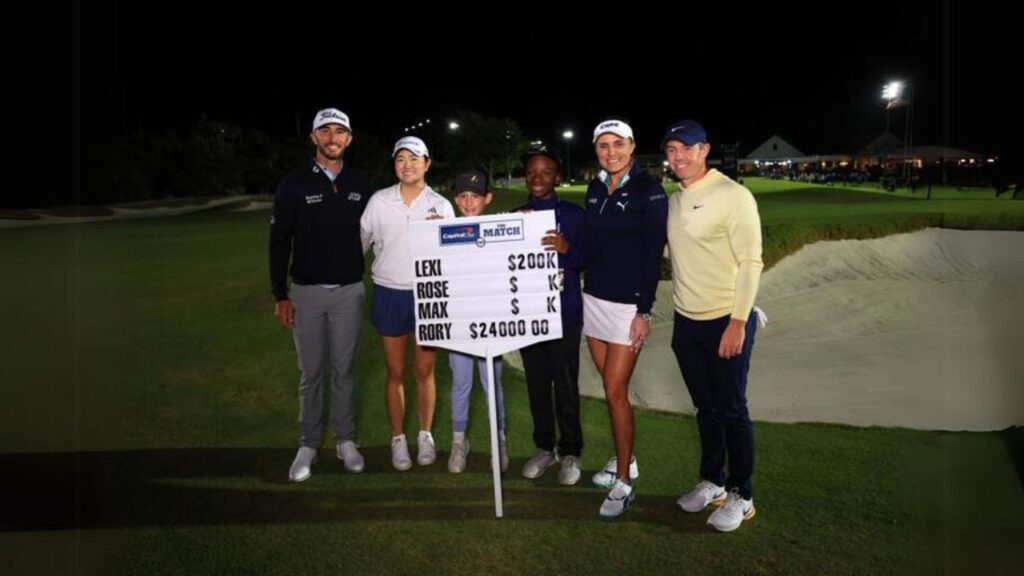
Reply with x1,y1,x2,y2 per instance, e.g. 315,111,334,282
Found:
669,169,764,321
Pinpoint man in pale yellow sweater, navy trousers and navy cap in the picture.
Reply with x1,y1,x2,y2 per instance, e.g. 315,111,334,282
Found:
662,120,764,532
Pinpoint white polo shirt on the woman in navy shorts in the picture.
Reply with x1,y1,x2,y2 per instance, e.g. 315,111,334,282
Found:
359,184,455,290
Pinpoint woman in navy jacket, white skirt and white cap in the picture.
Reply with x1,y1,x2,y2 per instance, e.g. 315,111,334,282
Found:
583,120,669,517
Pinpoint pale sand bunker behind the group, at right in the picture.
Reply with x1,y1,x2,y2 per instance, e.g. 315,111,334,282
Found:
509,229,1024,430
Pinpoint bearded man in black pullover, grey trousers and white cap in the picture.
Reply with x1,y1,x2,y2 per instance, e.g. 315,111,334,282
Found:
270,108,370,482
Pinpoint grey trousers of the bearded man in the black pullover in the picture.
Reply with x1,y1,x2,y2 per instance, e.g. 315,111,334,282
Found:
291,282,366,448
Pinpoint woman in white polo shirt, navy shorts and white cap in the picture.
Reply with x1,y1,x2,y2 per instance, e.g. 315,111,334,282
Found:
359,136,455,470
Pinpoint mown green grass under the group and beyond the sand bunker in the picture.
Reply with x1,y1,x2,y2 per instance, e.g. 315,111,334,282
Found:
0,190,1024,575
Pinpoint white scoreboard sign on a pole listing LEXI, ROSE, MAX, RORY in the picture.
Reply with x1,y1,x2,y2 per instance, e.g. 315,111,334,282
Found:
409,210,562,518
